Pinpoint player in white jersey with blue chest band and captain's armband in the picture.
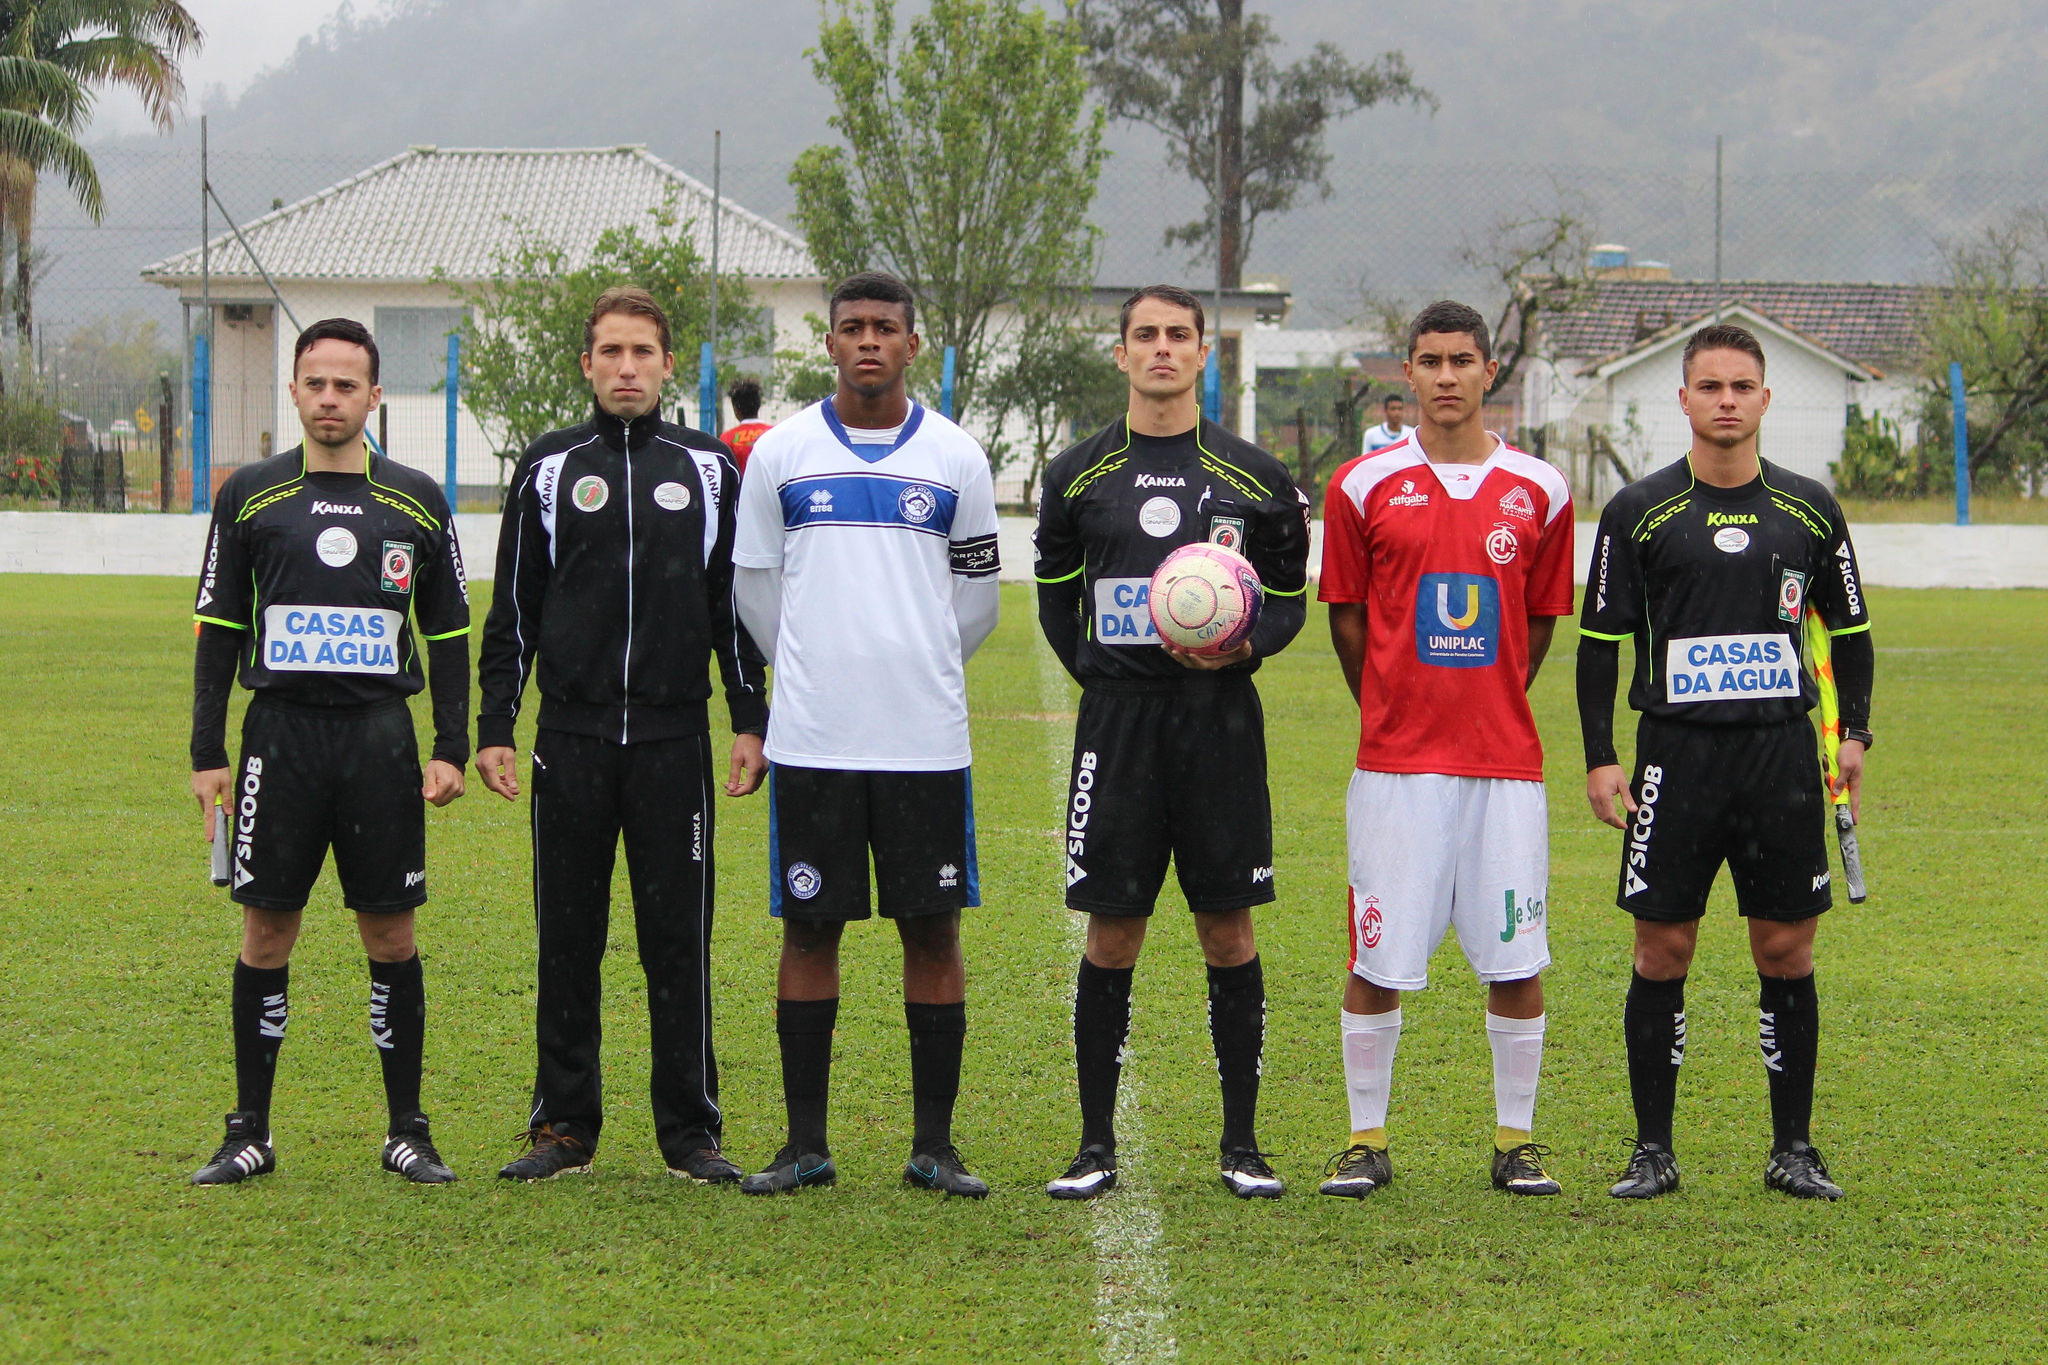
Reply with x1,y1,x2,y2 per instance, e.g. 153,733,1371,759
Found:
733,272,997,1199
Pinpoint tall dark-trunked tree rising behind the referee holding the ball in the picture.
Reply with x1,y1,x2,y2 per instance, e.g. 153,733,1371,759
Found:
1081,0,1436,289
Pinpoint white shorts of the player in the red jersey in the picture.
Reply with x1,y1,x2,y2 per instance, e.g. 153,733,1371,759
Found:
1343,769,1550,990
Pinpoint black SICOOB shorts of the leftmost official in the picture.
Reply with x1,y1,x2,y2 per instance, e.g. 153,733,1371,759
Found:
227,698,426,913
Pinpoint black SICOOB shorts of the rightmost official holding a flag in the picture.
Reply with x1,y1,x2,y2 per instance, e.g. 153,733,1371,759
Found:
1616,716,1835,923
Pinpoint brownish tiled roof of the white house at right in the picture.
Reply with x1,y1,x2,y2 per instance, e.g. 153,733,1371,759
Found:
1542,280,1933,370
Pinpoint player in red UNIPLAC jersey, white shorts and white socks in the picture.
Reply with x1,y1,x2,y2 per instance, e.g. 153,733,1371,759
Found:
1319,303,1571,1199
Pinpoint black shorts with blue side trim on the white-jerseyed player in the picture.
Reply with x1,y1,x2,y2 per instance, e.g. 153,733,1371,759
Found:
768,763,981,919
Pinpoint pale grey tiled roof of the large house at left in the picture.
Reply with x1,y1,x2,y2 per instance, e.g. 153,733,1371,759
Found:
141,147,817,284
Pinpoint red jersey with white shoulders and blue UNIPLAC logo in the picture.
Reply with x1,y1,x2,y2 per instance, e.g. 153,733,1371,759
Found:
1317,432,1571,782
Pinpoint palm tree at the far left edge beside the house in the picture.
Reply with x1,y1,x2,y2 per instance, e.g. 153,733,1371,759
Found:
0,0,201,374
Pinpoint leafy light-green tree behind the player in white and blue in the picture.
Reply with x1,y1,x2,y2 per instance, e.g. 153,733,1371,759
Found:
788,0,1104,427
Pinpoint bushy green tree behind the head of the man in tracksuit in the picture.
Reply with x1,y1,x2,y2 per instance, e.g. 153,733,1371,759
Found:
438,205,768,478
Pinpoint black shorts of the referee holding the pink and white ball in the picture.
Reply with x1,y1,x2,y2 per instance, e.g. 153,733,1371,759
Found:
1067,677,1274,915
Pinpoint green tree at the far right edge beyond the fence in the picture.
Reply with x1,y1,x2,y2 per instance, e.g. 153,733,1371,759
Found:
1921,209,2048,483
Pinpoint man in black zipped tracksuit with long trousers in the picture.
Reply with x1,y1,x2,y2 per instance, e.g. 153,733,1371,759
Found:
477,289,768,1183
